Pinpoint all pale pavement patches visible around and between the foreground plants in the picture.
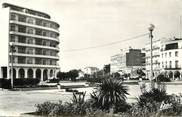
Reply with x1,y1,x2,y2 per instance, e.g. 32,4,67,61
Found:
0,85,182,116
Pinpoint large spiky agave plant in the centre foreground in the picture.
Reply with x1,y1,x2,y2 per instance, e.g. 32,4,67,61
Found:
91,79,128,110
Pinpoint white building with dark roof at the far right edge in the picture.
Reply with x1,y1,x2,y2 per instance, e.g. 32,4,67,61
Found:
160,38,182,78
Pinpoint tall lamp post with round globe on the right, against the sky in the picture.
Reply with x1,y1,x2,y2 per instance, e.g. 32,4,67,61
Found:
148,24,155,81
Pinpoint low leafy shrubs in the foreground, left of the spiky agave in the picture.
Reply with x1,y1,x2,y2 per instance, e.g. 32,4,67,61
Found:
35,93,90,116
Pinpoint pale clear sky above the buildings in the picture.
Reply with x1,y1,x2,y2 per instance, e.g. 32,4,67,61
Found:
0,0,182,71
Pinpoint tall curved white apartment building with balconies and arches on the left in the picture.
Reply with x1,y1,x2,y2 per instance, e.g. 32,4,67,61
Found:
0,3,59,81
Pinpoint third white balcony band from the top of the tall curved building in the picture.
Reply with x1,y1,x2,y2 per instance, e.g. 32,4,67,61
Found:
10,31,59,42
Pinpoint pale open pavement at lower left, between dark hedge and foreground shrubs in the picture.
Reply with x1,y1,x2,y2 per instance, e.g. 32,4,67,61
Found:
0,90,72,116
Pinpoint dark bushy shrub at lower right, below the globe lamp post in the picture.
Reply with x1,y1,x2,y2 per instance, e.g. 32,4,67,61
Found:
130,88,174,117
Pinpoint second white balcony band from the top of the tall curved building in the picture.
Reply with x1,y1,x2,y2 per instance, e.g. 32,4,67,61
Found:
10,20,59,33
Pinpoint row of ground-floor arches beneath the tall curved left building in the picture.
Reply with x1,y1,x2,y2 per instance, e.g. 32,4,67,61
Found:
0,67,59,81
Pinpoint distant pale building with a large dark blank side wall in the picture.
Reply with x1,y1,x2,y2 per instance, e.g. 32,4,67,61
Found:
111,49,145,76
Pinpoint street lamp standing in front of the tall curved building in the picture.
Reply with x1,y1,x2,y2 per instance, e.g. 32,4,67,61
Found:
9,42,15,89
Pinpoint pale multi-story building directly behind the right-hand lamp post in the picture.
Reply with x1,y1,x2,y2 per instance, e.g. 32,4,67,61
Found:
145,40,161,78
